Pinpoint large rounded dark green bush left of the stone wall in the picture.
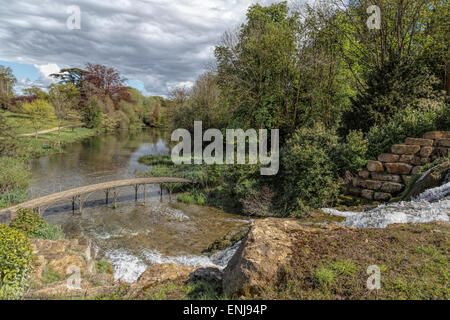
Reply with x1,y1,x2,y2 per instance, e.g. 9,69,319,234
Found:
277,125,338,214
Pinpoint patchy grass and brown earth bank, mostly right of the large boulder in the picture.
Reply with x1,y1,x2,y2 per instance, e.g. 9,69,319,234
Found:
115,223,450,300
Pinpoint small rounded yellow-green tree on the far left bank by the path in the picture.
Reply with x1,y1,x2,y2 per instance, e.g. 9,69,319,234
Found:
49,83,80,135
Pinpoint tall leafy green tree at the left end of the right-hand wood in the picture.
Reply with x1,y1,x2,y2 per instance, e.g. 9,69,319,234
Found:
215,2,299,135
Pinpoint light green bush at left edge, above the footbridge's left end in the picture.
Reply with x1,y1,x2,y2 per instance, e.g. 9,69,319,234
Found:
0,157,30,193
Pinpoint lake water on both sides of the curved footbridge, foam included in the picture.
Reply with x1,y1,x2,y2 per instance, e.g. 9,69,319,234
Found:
29,130,249,282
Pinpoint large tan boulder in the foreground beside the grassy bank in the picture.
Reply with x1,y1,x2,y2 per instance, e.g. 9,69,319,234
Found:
223,218,313,296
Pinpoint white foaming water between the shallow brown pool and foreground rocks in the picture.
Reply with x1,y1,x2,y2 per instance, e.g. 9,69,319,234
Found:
105,242,241,283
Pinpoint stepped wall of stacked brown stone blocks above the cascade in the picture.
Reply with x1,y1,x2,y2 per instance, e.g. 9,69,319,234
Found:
346,131,450,201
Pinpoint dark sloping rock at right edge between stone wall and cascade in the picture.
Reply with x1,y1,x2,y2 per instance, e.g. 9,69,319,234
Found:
404,160,450,200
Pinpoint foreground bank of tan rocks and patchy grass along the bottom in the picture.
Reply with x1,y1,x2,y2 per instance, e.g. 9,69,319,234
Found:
22,218,450,300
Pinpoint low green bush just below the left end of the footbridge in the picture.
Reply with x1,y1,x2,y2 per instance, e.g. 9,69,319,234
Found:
11,209,64,240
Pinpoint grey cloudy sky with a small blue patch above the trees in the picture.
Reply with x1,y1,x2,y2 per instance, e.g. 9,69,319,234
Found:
0,0,274,95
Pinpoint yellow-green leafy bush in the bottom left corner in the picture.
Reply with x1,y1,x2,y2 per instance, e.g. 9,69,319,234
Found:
0,225,32,300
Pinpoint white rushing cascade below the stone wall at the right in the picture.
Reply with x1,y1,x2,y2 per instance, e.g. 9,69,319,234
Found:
323,182,450,228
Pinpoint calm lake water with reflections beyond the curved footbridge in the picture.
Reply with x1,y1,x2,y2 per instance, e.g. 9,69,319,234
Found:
31,130,169,197
